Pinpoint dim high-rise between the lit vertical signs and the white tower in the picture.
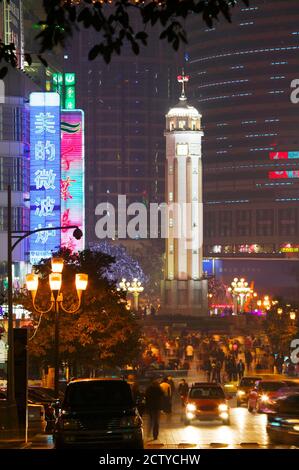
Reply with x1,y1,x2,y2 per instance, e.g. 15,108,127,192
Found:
64,26,182,243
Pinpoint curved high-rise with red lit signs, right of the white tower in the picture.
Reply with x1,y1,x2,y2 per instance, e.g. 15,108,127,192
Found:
189,0,299,258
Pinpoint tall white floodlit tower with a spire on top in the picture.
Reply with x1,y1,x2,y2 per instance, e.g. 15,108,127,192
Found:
161,72,208,316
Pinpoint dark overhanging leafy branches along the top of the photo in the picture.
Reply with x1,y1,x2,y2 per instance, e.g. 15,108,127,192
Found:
0,0,249,78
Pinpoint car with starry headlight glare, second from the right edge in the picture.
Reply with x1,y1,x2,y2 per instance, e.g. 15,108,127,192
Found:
248,380,287,413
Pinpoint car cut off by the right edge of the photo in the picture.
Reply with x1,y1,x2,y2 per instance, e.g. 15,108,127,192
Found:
267,392,299,446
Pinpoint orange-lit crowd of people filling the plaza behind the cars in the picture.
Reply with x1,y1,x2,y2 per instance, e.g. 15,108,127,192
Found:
142,328,299,383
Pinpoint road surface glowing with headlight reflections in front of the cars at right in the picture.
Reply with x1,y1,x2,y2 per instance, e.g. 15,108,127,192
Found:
20,399,298,449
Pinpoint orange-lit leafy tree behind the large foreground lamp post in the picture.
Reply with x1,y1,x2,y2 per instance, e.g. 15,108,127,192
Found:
18,249,140,375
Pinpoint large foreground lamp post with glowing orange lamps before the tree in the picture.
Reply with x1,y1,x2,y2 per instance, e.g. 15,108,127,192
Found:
26,258,88,397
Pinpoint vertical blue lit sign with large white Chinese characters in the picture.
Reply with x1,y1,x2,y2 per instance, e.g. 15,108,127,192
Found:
30,93,61,264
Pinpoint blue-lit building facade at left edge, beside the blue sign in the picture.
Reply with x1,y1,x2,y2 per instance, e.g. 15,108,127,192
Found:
0,67,37,284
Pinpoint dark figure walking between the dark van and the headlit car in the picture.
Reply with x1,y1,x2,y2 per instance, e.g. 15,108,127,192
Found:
145,380,164,440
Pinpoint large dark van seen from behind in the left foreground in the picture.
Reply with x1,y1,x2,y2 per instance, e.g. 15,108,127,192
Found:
54,379,143,449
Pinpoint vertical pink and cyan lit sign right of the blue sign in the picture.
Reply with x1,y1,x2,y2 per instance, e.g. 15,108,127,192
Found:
61,110,84,252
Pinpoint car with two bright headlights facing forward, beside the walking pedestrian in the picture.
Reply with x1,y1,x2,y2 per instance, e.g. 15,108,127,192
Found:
184,382,230,425
